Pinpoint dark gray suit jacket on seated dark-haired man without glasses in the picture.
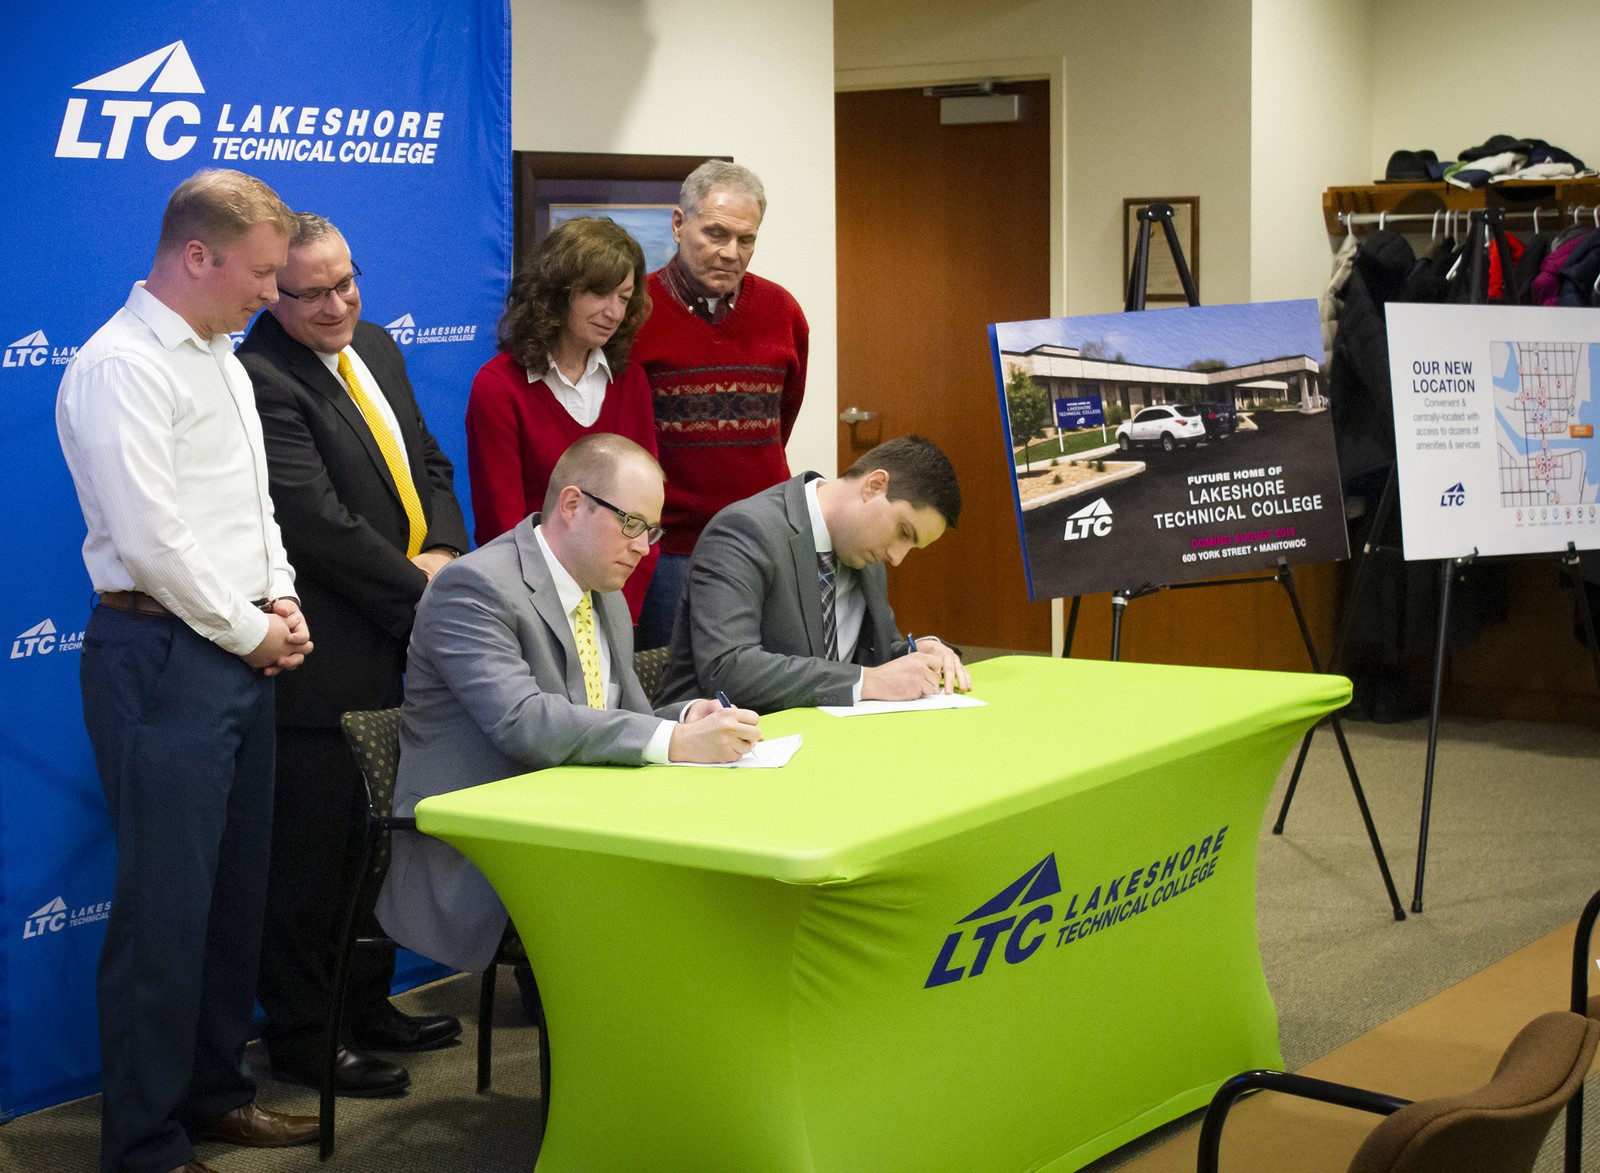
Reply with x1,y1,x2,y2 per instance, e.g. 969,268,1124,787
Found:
659,472,906,712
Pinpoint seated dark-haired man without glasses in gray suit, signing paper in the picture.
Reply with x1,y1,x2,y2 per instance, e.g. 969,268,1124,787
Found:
661,435,971,712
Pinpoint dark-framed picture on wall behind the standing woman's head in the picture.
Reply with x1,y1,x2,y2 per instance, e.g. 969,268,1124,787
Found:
512,150,731,272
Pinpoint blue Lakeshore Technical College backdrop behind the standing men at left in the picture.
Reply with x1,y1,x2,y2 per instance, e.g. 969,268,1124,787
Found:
0,0,510,1119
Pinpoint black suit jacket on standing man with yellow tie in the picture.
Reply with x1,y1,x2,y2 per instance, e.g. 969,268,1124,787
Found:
238,314,467,727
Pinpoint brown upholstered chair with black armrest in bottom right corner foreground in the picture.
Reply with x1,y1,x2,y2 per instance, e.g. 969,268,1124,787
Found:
1197,1010,1600,1173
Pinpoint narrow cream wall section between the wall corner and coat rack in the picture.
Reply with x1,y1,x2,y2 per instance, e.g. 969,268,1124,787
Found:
1250,0,1389,301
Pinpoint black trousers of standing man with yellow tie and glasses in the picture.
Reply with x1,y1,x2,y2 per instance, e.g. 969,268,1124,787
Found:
258,725,394,1063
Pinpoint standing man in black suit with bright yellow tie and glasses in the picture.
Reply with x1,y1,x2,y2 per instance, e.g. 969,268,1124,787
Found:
238,213,467,1096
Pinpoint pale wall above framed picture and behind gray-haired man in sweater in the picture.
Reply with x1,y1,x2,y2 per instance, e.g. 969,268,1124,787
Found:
510,0,837,472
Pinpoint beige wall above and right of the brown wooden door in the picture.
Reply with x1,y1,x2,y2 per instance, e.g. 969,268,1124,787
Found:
834,0,1251,314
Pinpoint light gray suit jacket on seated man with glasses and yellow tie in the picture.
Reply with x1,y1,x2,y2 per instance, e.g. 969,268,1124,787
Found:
378,514,678,970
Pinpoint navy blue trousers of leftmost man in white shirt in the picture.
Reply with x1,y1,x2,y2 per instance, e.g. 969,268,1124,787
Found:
80,607,274,1173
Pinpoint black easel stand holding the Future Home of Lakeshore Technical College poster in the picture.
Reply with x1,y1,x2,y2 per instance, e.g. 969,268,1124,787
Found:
1061,203,1401,920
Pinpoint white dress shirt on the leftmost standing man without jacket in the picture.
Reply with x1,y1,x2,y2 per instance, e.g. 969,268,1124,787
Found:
56,282,294,656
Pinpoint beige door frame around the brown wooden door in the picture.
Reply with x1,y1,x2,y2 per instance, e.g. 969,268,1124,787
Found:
834,58,1067,656
